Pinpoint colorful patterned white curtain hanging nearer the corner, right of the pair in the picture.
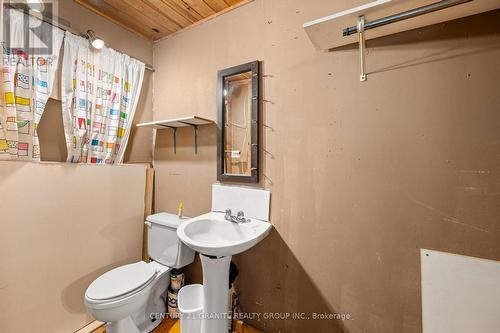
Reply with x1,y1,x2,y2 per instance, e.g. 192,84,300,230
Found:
61,32,145,164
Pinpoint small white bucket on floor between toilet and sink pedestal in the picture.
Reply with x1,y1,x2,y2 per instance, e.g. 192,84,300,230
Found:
177,284,203,333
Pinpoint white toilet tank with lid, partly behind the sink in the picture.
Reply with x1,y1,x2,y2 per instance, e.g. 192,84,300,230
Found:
146,213,194,268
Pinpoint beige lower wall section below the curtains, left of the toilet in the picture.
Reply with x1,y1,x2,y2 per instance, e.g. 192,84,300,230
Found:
0,161,146,333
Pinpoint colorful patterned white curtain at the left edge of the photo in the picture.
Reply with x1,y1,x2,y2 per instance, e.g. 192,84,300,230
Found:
0,9,64,161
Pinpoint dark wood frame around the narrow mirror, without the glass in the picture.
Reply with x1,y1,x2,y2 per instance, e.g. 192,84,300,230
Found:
217,61,260,183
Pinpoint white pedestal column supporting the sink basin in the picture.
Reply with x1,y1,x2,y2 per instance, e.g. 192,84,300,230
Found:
200,254,231,333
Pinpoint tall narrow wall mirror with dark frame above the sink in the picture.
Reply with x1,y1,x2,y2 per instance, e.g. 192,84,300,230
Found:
217,61,260,183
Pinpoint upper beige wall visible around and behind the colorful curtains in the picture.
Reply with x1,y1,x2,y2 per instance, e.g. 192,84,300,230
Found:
38,0,153,162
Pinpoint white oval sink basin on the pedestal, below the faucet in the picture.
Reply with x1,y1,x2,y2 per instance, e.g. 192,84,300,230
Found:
177,212,272,257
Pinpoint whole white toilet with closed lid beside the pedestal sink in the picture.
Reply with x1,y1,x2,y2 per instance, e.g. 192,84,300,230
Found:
85,213,194,333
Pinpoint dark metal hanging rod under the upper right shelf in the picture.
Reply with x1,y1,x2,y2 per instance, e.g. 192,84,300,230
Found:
342,0,474,37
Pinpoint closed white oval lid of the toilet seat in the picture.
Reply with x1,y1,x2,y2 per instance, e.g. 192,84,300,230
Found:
87,261,156,300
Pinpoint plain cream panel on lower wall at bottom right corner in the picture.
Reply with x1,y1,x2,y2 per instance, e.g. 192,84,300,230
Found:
420,249,500,333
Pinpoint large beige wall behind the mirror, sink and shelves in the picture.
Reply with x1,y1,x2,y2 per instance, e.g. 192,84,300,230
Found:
154,0,500,333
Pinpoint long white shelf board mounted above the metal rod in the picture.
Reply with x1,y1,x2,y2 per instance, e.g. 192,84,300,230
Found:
303,0,500,50
